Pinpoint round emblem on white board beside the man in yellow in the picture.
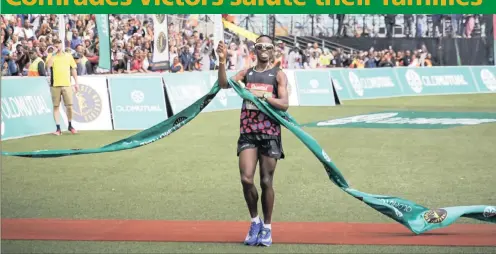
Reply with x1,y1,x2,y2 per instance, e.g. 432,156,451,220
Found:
72,84,102,123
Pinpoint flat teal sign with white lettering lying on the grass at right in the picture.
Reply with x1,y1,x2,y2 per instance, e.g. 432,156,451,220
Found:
302,111,496,129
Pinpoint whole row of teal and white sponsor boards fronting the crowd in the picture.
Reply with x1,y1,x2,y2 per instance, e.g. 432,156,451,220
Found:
1,66,496,140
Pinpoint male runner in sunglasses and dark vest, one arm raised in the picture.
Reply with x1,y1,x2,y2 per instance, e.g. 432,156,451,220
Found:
217,35,289,246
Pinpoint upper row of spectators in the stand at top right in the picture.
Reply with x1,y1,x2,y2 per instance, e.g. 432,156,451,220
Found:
318,14,492,38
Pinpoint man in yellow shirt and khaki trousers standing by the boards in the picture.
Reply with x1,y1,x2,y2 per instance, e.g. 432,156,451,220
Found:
47,40,79,136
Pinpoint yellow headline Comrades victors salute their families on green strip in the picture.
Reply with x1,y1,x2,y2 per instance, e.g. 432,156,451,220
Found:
2,0,484,7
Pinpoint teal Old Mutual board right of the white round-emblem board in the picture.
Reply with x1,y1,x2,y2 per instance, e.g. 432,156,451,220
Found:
108,76,167,130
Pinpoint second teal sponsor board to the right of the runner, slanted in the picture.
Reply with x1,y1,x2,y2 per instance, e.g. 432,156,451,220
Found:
342,68,403,99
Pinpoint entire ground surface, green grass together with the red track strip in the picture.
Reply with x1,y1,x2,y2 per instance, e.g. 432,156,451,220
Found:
2,94,496,253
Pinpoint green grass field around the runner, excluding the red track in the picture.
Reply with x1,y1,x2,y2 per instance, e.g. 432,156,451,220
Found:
1,94,496,253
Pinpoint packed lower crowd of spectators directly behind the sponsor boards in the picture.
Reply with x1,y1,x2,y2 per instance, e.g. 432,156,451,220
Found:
0,14,462,76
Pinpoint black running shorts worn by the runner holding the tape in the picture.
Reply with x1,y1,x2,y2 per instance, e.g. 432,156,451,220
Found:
237,134,285,160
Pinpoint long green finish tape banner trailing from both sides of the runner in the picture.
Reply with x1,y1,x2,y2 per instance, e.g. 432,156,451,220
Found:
2,80,496,234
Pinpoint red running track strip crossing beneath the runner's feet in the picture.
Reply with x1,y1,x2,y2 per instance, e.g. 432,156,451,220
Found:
1,219,496,246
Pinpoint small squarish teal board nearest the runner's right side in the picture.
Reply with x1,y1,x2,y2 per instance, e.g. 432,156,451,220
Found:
295,71,336,106
